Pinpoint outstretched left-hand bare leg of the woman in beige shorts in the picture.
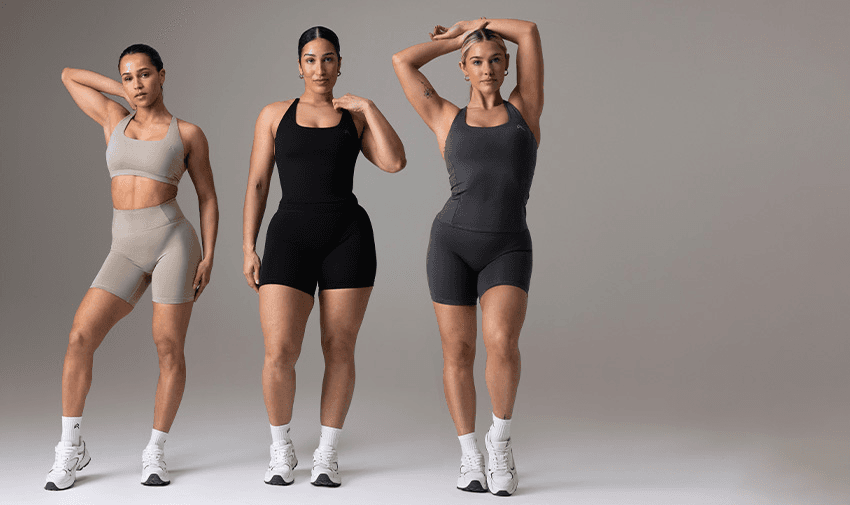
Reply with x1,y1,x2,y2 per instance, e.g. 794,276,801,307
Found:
62,288,133,417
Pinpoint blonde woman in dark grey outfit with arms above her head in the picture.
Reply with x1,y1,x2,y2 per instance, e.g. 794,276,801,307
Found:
393,18,543,495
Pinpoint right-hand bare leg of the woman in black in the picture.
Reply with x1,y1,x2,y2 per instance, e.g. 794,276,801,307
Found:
319,287,372,428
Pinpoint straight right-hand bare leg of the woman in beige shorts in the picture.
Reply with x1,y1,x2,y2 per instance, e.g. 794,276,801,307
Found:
153,302,194,433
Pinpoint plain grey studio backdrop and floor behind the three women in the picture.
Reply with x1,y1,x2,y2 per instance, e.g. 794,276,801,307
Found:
0,0,850,504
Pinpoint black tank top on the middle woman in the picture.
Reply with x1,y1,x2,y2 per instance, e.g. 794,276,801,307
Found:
274,98,360,204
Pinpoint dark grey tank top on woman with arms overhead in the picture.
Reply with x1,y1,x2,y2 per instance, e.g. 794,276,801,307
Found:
437,101,537,232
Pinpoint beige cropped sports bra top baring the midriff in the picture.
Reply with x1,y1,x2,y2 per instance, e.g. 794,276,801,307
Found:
106,111,186,186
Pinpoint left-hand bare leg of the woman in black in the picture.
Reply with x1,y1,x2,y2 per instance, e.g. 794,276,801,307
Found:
260,284,313,426
